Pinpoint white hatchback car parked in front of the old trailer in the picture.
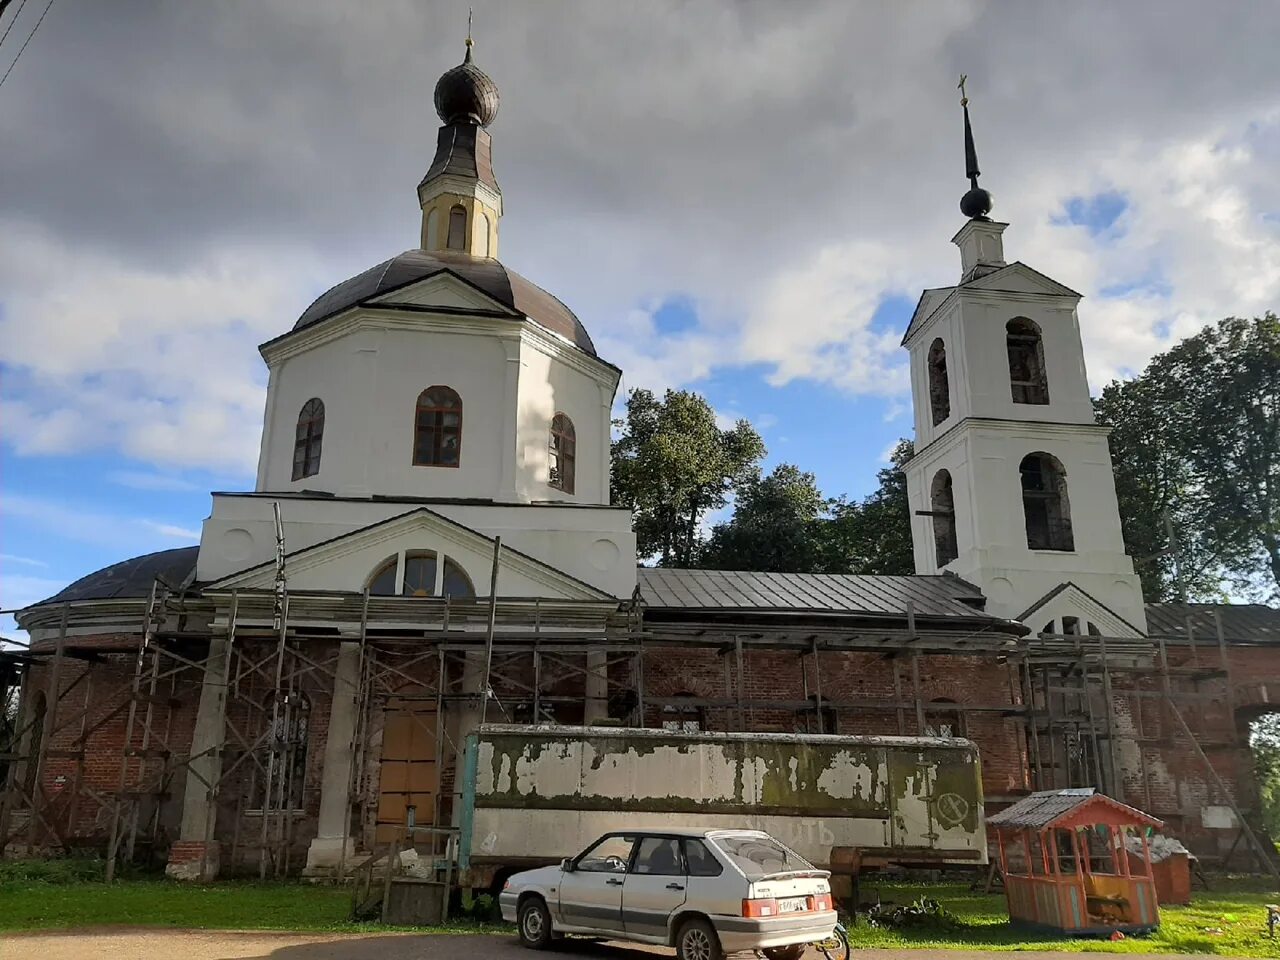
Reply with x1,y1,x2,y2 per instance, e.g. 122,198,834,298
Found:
499,829,836,960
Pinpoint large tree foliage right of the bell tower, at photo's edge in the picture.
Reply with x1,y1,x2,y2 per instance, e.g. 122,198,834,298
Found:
1094,314,1280,600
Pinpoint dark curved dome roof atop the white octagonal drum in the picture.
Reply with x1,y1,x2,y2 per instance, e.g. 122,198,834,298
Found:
293,250,596,357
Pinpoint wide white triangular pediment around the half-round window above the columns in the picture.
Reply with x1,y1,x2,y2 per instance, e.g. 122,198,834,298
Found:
206,507,614,600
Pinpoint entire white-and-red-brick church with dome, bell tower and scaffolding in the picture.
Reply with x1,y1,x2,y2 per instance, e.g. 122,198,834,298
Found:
0,38,1280,882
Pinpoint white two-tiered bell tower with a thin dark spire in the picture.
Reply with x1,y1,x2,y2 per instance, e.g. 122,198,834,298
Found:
902,78,1146,636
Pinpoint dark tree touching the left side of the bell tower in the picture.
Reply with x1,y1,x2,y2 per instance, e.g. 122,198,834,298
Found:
827,440,915,575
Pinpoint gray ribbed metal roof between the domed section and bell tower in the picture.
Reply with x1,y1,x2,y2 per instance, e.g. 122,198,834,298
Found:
637,567,991,620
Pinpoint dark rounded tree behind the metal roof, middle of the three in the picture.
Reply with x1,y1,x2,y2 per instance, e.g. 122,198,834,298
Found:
699,463,828,573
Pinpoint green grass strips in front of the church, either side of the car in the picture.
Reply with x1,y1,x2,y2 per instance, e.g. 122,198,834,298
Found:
0,860,1280,957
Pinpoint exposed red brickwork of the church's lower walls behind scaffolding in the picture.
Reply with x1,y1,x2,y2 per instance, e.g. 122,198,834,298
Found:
12,635,1280,876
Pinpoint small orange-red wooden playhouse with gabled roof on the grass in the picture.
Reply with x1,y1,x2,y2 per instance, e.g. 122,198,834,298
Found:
987,787,1164,936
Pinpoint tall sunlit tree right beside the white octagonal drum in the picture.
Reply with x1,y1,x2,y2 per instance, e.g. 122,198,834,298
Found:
612,390,764,567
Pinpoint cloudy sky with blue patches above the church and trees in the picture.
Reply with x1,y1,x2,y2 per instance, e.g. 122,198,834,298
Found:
0,0,1280,627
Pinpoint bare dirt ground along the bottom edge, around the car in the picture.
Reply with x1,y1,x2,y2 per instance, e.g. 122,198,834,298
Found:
0,929,1254,960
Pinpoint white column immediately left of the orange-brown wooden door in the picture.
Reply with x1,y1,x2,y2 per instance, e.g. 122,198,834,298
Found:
303,640,360,876
